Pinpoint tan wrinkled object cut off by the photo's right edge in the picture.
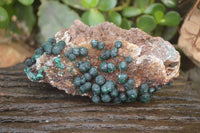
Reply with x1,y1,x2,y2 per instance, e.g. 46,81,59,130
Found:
178,8,200,67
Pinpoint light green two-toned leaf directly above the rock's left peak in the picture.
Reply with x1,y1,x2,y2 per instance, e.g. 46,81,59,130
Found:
81,9,105,26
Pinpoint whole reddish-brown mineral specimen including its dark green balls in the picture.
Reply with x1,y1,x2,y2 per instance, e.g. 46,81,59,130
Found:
24,20,180,103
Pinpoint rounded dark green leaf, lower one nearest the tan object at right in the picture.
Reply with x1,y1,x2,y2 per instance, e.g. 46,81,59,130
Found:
159,11,181,26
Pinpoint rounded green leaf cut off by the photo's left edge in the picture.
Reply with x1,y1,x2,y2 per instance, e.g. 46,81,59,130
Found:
0,7,9,28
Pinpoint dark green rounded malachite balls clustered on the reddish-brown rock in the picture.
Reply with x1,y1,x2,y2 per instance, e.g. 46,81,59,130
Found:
24,38,166,103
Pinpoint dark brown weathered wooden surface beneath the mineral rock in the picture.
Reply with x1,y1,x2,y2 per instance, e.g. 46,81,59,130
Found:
0,64,200,133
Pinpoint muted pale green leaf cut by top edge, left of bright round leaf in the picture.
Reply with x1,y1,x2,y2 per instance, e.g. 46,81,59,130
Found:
62,0,86,10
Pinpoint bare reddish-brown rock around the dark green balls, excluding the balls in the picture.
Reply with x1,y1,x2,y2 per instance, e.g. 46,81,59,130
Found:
25,20,180,102
